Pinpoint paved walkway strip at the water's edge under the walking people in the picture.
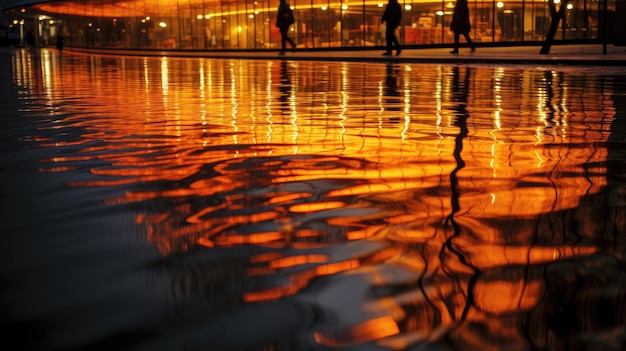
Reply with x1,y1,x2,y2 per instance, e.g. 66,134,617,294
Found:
68,44,626,66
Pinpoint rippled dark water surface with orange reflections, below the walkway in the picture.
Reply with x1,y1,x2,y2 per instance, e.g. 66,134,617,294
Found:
0,50,626,350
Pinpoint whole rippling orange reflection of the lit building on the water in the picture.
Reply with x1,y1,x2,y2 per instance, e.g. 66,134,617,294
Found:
15,52,624,348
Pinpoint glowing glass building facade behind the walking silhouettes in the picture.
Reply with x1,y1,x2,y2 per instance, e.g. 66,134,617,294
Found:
5,0,619,50
